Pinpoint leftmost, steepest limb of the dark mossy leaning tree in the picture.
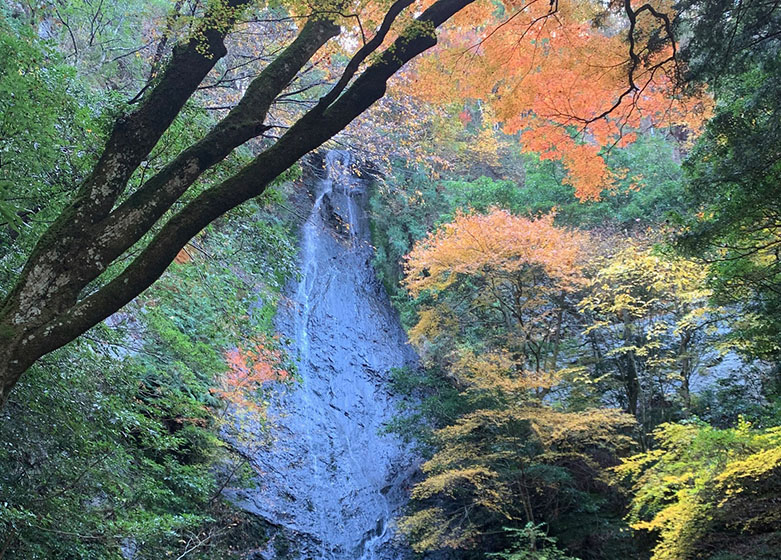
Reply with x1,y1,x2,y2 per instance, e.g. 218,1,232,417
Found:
0,0,250,336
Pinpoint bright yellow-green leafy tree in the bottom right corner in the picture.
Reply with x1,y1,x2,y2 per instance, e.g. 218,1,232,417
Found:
616,421,781,560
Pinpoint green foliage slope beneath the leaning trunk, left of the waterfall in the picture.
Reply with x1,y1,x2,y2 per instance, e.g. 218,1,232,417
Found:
0,200,295,560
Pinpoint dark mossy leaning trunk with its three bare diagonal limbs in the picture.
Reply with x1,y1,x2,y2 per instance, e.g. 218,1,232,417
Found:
0,0,473,404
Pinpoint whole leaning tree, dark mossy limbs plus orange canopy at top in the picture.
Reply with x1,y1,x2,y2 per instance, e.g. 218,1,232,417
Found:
0,0,705,400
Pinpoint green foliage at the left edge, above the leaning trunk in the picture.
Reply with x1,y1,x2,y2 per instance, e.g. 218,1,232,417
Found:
0,11,107,294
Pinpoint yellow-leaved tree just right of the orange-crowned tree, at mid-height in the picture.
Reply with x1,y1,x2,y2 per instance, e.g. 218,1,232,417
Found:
579,245,718,427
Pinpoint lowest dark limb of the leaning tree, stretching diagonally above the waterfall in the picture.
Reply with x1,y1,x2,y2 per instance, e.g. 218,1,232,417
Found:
35,0,474,360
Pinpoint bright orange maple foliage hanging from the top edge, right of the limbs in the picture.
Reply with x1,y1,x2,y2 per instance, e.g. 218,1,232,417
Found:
404,0,711,199
